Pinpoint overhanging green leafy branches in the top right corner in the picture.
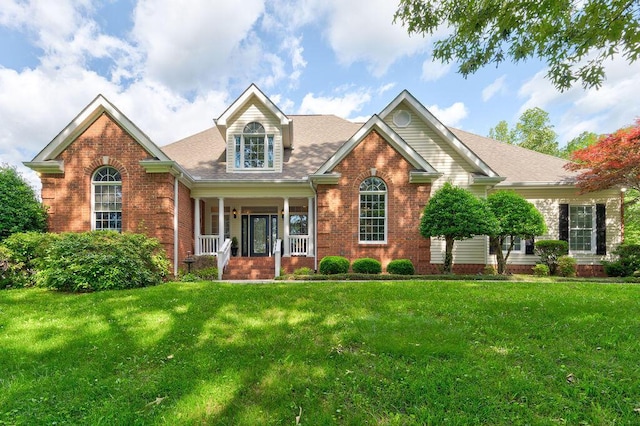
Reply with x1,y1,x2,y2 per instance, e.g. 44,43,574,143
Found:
394,0,640,91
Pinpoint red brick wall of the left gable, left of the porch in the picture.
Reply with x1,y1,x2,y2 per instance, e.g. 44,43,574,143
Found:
41,113,186,272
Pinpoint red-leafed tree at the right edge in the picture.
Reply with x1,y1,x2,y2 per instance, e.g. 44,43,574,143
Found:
565,119,640,202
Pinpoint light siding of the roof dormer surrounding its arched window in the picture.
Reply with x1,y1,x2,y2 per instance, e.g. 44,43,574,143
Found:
227,102,283,173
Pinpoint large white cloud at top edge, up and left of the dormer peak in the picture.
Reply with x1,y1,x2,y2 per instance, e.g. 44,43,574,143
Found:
132,0,264,91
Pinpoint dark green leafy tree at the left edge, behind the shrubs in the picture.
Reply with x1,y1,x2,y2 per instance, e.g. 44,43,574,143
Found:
0,165,47,241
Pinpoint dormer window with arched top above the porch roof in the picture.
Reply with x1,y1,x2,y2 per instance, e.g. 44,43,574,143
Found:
235,121,273,169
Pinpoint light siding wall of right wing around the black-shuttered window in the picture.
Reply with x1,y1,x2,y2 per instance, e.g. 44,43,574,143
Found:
491,188,622,265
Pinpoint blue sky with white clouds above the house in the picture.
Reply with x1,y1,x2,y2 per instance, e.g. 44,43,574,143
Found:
0,0,640,189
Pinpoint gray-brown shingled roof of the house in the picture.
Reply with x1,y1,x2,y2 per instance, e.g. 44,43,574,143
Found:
161,115,575,185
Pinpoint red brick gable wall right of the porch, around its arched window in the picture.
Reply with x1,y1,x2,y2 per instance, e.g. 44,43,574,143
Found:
317,131,431,274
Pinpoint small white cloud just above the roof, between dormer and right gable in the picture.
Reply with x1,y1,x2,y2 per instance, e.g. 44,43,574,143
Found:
298,89,371,119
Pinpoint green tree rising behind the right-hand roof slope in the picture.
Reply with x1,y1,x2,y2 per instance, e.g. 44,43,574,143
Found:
489,107,559,155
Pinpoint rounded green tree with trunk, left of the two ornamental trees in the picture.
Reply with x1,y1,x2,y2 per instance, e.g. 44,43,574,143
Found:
420,182,498,274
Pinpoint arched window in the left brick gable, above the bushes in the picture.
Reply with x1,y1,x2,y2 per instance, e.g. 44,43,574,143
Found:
91,167,122,232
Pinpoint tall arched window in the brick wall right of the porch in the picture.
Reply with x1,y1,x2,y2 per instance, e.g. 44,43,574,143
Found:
359,176,387,243
